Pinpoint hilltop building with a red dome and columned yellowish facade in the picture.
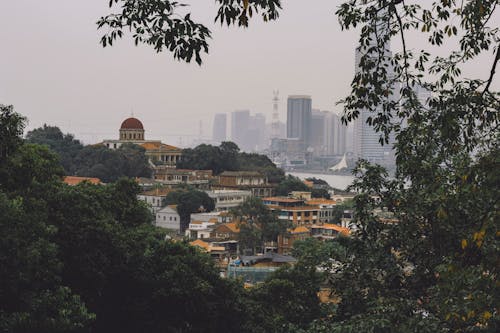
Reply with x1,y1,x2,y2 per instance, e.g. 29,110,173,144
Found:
101,117,182,167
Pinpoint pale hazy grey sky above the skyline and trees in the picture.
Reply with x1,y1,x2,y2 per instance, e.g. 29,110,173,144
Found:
0,0,499,145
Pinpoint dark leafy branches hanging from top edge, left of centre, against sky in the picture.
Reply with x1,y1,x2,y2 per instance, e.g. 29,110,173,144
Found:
97,0,281,64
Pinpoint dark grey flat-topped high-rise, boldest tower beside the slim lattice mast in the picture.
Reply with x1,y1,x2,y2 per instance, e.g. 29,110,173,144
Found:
286,95,312,147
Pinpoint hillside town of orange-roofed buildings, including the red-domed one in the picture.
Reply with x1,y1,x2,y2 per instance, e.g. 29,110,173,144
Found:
64,117,355,282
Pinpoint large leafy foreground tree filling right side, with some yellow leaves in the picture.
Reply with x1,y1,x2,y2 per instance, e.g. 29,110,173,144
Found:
304,0,500,332
